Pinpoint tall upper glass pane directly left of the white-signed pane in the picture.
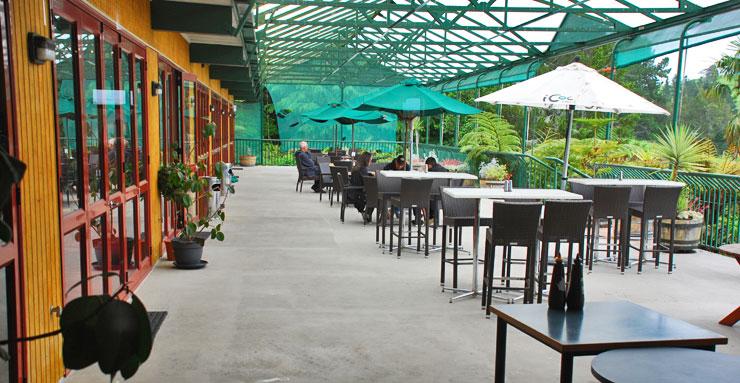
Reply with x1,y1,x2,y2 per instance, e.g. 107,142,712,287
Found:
80,32,104,203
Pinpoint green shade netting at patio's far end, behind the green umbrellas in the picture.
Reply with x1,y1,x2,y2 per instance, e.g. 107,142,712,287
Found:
267,84,396,142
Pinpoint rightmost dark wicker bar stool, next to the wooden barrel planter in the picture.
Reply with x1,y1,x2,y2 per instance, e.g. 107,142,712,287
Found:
625,186,683,274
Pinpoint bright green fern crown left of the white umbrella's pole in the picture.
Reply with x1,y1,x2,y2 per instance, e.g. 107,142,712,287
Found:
460,112,522,169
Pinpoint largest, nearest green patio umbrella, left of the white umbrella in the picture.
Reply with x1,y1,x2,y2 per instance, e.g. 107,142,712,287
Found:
347,79,481,166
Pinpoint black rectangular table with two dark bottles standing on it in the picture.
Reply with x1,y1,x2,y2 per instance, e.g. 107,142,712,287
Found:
490,301,727,383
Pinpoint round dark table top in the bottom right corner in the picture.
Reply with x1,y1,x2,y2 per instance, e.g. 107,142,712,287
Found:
591,348,740,383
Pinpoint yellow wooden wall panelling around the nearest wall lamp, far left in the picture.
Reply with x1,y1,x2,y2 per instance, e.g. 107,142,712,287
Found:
10,0,64,382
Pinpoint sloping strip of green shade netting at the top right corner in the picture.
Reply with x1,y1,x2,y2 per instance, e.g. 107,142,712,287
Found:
614,10,740,68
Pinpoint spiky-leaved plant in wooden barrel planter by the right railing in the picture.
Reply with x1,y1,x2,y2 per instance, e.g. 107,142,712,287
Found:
655,125,714,251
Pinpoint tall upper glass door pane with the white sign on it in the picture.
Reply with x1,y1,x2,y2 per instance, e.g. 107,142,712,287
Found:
105,41,121,193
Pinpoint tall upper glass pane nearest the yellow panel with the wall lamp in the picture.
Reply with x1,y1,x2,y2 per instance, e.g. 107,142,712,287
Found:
54,15,82,214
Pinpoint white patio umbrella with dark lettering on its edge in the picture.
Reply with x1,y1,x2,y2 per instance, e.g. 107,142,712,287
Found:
475,62,669,189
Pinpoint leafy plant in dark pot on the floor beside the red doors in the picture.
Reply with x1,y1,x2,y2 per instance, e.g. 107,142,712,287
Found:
157,161,227,268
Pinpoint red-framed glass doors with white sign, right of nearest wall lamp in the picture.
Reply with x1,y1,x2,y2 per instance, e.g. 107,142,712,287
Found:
52,1,151,303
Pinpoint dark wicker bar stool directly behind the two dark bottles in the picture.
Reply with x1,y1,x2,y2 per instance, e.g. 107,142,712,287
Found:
537,200,592,303
